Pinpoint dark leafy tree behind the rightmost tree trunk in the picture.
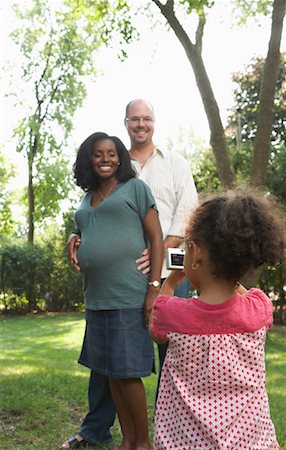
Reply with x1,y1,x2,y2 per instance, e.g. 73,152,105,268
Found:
226,53,286,202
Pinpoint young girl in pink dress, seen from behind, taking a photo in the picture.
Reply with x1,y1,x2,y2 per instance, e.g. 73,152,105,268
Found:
149,189,285,450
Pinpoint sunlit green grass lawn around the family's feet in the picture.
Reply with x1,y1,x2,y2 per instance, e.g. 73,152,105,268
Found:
0,313,286,450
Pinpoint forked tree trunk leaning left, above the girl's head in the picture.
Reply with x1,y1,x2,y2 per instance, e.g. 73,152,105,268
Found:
153,0,235,187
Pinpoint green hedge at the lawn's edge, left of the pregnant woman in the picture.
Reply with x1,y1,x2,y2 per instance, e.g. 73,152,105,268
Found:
0,213,83,313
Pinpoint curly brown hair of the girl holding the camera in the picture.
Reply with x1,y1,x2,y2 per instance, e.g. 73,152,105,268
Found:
185,187,286,281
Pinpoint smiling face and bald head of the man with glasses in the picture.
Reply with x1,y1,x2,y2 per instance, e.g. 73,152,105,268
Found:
125,101,155,146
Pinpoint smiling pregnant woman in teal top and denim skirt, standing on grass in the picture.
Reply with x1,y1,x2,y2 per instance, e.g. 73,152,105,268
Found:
62,132,163,450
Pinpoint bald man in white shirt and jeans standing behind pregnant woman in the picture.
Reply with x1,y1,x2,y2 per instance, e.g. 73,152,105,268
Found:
63,99,197,448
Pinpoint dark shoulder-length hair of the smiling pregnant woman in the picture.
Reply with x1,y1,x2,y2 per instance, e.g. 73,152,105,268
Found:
73,132,136,192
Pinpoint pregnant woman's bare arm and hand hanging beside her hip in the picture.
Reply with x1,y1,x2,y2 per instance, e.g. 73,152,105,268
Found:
143,208,163,326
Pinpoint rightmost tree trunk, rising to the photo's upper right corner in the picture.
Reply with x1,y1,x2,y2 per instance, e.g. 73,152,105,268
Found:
251,0,286,185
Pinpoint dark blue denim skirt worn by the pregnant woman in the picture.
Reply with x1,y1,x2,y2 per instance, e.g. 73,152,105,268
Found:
78,308,154,378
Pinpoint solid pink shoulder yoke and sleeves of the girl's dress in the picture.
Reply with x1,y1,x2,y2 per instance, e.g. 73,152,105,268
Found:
154,288,273,334
